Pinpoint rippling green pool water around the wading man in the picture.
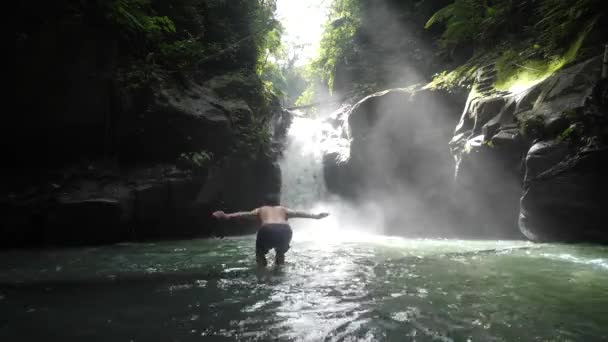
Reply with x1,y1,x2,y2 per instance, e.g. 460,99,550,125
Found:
0,230,608,341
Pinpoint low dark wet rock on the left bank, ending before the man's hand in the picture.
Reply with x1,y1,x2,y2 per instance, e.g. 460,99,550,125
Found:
0,165,205,246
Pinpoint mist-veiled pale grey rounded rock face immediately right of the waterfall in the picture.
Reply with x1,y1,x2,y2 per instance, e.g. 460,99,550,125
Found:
324,89,463,236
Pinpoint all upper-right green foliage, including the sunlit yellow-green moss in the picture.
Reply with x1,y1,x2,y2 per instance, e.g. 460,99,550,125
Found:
425,0,605,90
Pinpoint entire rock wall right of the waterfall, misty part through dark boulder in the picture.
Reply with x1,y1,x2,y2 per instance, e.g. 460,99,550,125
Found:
324,57,608,242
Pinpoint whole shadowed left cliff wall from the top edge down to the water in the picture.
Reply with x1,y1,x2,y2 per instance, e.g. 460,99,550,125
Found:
0,1,289,247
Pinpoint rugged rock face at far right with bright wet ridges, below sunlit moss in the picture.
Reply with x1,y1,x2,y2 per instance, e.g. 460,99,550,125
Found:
450,58,608,242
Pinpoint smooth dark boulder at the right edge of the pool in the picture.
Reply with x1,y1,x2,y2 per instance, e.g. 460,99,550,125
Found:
519,141,608,243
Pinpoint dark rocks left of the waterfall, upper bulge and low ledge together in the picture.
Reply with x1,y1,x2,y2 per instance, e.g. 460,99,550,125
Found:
0,74,289,247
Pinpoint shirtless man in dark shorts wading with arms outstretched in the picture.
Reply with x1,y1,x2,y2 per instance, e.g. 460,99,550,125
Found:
213,206,329,266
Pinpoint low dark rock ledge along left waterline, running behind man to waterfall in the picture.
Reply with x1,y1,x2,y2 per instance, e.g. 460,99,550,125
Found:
0,151,281,247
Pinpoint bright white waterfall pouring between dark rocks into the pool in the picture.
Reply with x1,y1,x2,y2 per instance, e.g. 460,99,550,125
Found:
279,109,383,240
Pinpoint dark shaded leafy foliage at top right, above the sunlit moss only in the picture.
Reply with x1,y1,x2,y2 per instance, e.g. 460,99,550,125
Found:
425,0,601,57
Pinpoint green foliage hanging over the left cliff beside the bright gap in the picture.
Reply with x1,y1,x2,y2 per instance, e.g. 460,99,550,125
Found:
107,0,285,160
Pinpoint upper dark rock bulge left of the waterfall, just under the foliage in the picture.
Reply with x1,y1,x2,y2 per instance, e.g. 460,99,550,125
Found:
120,77,247,161
